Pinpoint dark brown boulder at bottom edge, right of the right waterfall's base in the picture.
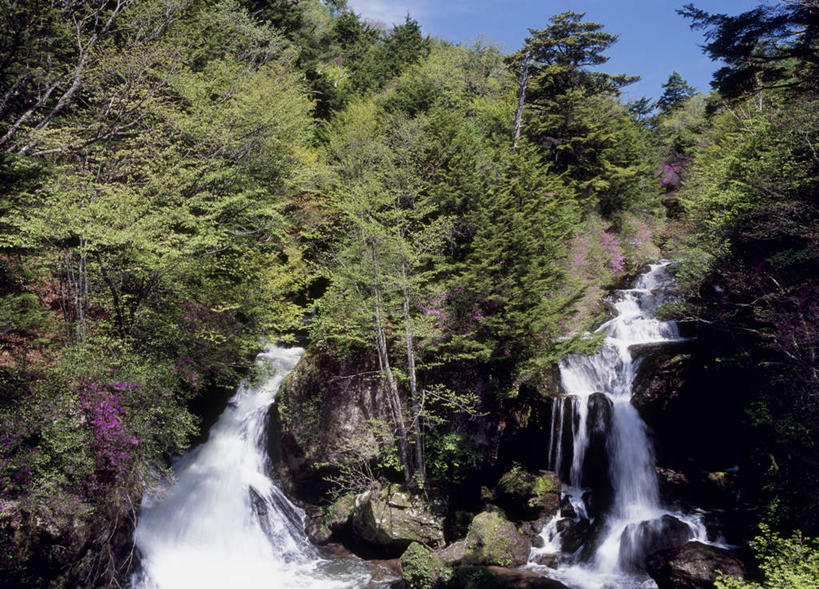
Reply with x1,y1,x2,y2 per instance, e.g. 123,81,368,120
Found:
646,542,745,589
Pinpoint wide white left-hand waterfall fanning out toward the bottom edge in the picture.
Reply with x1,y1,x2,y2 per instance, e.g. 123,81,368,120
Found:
131,346,369,589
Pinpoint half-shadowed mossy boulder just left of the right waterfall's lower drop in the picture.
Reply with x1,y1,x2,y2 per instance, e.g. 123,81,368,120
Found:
498,464,560,520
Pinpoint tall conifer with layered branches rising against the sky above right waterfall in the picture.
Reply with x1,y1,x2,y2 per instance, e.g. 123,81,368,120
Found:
512,12,651,218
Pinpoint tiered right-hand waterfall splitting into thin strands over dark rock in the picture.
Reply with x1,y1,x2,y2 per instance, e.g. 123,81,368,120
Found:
532,262,706,589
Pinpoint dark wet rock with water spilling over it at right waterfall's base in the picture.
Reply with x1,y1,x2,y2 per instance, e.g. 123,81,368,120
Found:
619,515,694,570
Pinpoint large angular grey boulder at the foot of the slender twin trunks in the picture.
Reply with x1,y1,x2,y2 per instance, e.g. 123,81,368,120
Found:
351,489,444,551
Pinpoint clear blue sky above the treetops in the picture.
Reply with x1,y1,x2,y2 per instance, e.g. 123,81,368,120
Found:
348,0,776,99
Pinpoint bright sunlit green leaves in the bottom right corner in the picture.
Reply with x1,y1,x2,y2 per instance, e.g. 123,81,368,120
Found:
715,524,819,589
